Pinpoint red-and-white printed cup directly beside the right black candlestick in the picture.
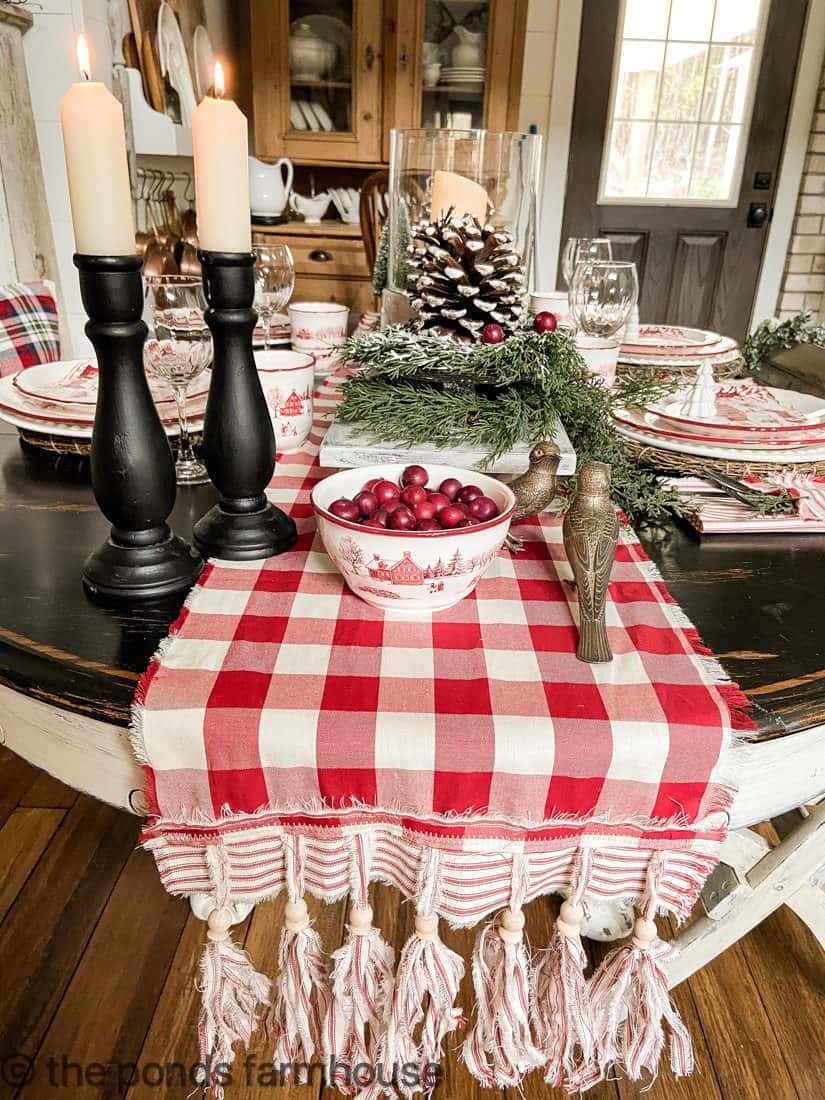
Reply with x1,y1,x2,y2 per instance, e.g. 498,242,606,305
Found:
255,349,315,451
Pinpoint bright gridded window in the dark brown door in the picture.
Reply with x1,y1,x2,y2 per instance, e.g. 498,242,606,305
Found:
600,0,769,206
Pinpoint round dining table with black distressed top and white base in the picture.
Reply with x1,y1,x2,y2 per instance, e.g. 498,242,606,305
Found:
0,422,825,985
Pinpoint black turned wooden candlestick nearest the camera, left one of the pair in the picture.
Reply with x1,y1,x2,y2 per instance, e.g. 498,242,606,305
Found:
75,255,204,602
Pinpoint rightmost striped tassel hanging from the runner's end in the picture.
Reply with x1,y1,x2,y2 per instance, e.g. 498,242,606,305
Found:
587,855,693,1084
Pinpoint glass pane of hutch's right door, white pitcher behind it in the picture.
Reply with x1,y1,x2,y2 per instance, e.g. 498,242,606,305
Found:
420,0,491,130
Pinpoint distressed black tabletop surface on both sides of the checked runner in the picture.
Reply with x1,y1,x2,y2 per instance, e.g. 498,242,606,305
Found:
0,427,825,818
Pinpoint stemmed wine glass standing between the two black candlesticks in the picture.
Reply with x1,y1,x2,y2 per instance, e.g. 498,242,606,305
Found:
143,275,212,485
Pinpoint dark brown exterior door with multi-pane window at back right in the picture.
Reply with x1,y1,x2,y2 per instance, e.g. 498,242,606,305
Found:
558,0,807,339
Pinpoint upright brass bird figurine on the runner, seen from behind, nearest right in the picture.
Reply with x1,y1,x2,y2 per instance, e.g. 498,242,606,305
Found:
562,462,619,663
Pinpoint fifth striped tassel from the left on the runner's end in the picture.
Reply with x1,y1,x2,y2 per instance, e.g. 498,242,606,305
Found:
463,909,545,1089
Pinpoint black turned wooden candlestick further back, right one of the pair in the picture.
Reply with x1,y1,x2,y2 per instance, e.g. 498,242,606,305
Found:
195,252,297,560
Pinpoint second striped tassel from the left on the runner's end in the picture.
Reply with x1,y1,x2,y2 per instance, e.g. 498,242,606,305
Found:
268,836,331,1078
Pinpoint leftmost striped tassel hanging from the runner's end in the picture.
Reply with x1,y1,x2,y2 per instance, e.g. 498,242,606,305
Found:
198,847,272,1100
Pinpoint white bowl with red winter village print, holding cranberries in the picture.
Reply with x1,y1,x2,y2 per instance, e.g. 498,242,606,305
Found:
310,462,516,618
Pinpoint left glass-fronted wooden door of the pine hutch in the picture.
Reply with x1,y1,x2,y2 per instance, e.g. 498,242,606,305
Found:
250,0,383,165
